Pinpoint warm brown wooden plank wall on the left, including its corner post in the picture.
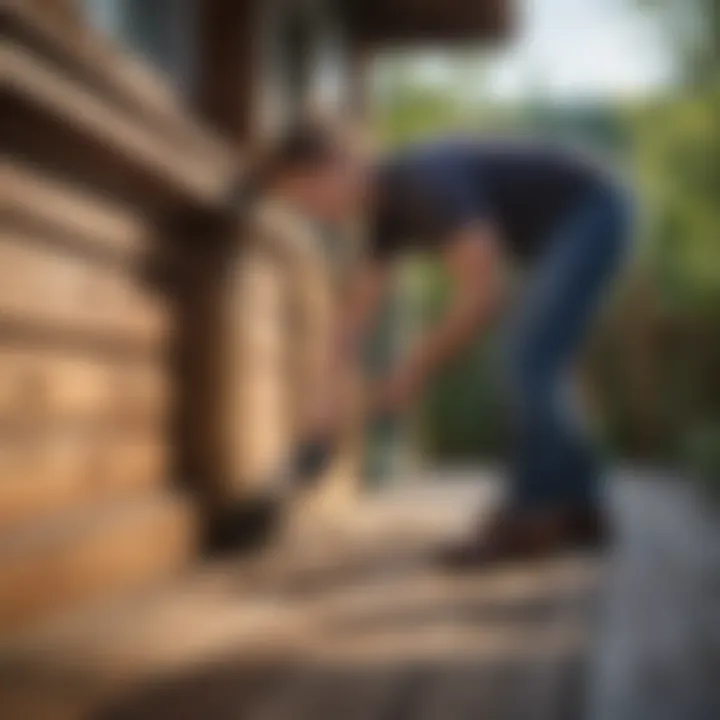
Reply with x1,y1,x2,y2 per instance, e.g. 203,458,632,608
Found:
0,0,366,631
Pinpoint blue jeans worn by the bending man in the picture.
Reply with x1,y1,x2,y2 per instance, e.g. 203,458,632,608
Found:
507,185,631,508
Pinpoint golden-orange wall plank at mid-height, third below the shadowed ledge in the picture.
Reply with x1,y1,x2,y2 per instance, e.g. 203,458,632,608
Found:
0,346,170,428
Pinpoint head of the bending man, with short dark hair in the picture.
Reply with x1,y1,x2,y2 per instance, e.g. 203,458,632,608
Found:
260,124,367,224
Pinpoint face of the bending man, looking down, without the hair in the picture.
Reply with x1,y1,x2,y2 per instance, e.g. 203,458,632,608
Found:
278,159,363,225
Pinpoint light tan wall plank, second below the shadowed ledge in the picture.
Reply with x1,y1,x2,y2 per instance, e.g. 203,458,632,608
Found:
0,232,170,343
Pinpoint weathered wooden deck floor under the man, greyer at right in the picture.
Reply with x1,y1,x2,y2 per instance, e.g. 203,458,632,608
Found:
0,472,720,720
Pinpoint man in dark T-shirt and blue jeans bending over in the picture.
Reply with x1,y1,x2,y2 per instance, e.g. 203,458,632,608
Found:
258,126,629,565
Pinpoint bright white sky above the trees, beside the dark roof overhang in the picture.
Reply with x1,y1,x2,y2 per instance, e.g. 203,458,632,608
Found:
380,0,673,101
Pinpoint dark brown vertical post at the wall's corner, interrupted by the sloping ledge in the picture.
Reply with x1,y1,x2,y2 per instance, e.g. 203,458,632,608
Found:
176,0,261,520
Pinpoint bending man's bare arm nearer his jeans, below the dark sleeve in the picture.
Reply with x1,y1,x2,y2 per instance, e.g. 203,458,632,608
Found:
379,224,505,411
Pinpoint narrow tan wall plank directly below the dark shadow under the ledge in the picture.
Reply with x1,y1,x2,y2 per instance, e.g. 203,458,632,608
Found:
0,160,153,258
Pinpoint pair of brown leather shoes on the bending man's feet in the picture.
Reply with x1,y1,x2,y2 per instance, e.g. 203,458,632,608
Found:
440,507,607,569
